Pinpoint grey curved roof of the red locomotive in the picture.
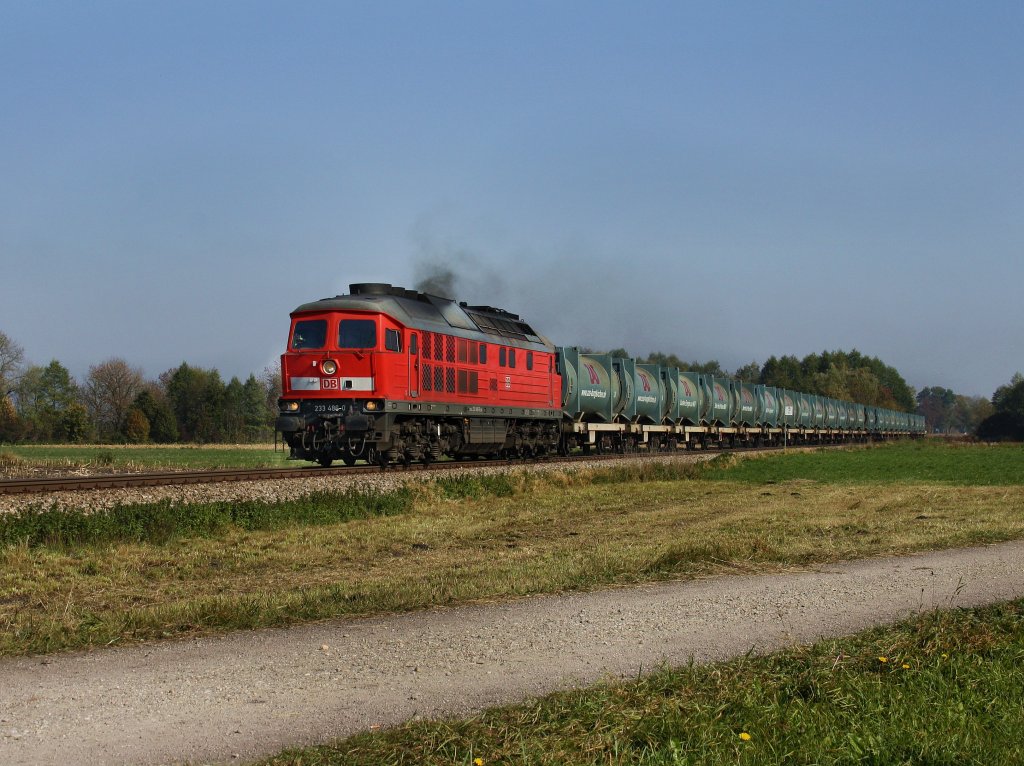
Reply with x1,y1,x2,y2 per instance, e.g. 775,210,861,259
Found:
292,284,553,351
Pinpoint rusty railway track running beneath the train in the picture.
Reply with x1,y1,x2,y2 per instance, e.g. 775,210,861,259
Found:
0,444,849,495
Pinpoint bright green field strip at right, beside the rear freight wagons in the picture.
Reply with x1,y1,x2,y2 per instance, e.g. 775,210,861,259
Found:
703,440,1024,486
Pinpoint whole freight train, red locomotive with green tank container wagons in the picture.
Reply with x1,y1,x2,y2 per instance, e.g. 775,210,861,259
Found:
276,284,925,466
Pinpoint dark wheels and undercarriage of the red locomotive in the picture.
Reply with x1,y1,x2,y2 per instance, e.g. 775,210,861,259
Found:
285,415,561,466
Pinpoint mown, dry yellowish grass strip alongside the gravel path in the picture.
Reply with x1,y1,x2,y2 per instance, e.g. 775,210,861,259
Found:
0,474,1024,653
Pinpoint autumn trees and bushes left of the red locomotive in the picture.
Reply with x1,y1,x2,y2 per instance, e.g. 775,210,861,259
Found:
0,332,281,443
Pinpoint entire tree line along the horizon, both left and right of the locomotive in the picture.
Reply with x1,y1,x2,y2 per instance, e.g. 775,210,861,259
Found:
0,331,1024,443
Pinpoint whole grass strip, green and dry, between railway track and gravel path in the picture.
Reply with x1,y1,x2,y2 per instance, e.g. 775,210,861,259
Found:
0,444,1024,654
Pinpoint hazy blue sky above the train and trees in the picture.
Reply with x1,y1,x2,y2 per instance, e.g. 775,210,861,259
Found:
0,0,1024,396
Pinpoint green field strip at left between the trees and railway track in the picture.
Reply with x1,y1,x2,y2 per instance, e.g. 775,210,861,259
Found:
0,444,288,475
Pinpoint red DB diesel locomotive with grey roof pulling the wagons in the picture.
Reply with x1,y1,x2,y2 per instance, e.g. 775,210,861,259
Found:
276,284,562,466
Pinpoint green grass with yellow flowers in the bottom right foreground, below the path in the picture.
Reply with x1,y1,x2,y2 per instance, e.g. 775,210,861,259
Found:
261,601,1024,766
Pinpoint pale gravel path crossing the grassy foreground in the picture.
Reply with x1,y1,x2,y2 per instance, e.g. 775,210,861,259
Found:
0,543,1024,766
